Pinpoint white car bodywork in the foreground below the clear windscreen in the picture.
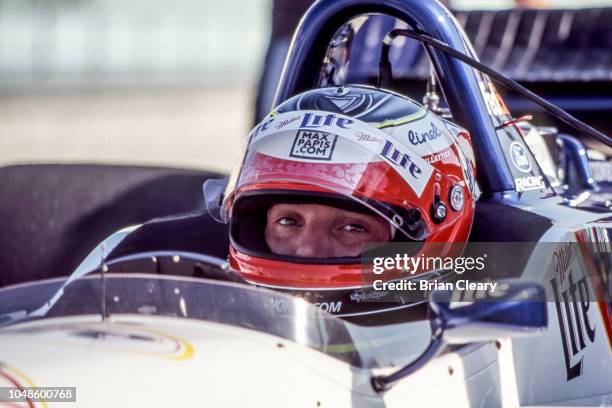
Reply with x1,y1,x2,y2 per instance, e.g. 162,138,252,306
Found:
0,315,501,407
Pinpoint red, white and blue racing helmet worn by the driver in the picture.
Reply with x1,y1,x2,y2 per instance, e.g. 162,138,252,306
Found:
204,85,475,326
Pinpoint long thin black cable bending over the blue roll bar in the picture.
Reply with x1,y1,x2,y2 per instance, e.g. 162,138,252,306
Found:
378,29,612,147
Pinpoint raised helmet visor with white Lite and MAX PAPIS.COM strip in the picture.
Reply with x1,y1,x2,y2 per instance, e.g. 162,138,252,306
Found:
205,111,458,240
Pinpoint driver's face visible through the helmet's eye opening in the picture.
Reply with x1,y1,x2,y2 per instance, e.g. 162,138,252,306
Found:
266,204,391,258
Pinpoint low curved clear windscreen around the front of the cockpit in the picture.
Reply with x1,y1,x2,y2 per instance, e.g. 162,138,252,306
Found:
0,274,430,368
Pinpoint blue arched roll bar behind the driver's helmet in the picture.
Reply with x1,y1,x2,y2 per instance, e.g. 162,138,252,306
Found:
274,0,514,193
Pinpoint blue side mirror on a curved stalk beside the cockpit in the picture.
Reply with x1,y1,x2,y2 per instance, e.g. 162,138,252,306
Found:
372,280,548,392
